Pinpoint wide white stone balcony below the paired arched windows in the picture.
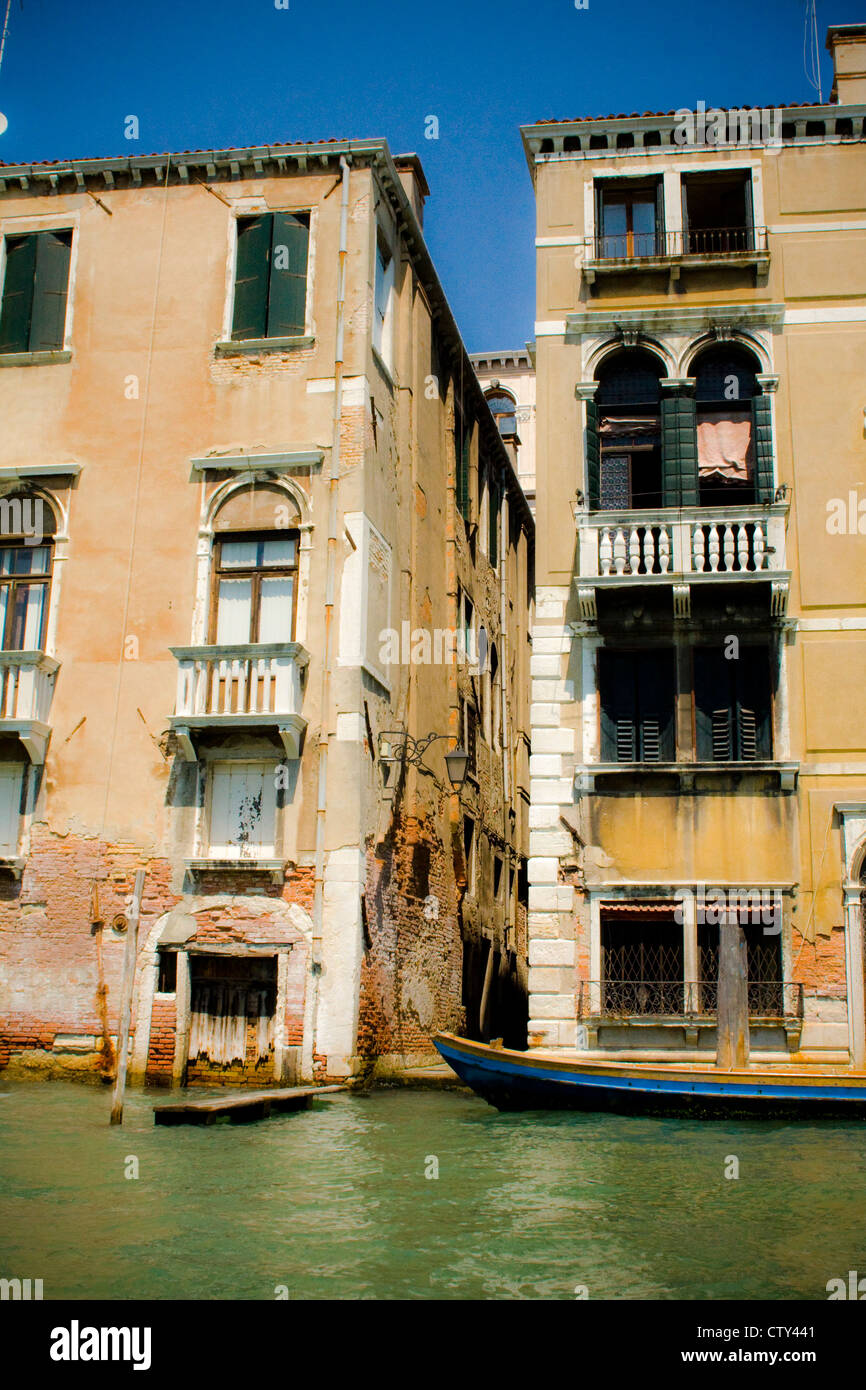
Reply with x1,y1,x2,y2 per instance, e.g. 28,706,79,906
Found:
574,502,791,621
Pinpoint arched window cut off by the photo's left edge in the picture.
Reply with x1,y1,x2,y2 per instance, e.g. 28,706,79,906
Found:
0,493,56,652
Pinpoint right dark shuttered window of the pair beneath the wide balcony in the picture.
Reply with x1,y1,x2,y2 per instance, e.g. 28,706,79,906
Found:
694,646,773,763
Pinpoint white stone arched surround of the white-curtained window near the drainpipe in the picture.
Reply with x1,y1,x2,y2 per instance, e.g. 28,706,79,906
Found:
190,475,313,646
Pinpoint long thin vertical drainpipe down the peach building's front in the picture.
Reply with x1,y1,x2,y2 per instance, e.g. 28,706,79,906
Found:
303,154,349,1076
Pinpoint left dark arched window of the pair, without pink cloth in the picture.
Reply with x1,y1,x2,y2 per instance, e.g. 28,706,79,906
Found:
591,348,663,509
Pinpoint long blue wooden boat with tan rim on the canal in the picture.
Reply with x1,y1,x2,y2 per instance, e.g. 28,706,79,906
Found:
434,1033,866,1119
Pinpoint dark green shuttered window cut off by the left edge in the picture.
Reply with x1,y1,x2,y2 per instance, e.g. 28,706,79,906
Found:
0,231,72,353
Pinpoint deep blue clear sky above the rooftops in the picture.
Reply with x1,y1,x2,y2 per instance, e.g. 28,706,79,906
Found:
0,0,866,352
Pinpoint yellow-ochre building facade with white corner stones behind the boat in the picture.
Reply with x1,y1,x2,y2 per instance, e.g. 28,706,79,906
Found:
523,26,866,1068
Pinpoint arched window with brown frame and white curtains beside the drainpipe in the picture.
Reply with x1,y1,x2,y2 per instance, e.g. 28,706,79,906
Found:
210,487,299,646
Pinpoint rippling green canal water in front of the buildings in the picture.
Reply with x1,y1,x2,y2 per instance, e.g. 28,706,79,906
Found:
0,1083,866,1300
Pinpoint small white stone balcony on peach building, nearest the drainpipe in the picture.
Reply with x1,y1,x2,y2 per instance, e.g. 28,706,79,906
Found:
171,642,310,762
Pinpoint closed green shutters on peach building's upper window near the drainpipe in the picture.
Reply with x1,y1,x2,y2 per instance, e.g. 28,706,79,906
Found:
232,213,310,341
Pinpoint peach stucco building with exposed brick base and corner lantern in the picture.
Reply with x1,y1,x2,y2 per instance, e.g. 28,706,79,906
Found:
0,140,532,1084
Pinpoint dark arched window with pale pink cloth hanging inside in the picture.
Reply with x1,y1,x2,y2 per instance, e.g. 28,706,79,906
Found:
692,343,760,506
